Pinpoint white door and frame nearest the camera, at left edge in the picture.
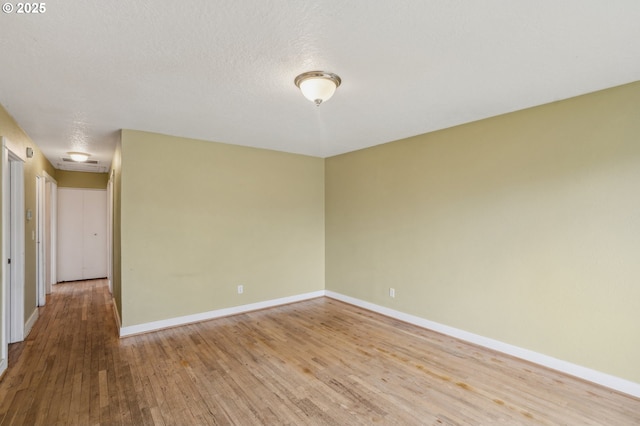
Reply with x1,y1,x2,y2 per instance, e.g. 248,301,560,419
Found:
0,137,25,373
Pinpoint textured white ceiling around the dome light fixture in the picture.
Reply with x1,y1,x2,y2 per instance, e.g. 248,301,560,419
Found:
0,0,640,171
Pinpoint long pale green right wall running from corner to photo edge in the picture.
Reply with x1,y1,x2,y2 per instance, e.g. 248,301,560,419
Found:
325,83,640,382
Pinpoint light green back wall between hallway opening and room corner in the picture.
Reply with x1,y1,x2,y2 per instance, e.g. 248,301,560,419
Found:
121,130,324,326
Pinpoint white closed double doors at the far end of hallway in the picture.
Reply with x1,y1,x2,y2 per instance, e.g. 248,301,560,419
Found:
57,188,107,282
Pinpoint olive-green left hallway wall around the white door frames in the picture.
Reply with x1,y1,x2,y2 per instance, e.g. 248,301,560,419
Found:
0,105,56,327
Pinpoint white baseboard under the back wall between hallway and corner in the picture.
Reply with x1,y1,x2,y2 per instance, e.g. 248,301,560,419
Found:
120,290,325,337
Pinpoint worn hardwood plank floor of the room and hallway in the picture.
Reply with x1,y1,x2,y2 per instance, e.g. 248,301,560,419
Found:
0,280,640,425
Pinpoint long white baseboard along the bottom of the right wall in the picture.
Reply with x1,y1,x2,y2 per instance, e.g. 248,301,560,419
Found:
325,290,640,398
